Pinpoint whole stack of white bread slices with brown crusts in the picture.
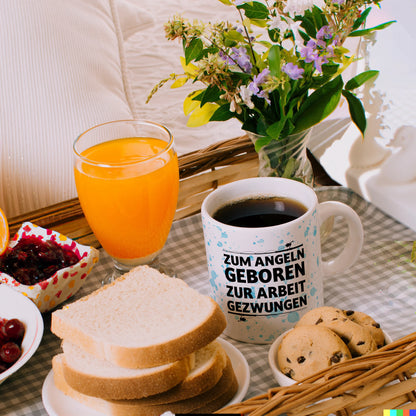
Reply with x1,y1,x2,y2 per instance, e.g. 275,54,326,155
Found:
51,266,238,416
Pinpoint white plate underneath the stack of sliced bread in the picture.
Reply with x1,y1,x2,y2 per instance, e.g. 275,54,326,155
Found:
42,338,250,416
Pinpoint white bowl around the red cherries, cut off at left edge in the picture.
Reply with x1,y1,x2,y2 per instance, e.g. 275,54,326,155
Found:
0,283,43,384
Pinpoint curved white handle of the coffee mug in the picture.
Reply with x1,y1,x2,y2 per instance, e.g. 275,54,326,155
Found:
318,201,364,275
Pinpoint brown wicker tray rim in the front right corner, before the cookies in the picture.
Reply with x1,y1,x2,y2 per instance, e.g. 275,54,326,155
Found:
216,332,416,416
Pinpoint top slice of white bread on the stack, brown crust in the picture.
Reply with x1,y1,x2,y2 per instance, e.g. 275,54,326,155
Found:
51,266,226,368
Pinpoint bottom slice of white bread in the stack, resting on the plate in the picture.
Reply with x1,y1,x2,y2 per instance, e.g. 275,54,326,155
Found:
52,354,238,416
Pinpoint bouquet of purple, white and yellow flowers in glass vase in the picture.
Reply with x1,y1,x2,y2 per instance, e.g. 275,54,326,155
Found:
148,0,393,181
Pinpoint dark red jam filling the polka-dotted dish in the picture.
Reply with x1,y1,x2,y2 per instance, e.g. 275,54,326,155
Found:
0,236,80,285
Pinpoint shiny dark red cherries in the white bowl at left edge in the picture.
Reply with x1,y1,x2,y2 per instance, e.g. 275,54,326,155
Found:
0,318,25,373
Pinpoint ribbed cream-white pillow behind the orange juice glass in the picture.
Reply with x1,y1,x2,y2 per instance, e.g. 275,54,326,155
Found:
0,0,140,217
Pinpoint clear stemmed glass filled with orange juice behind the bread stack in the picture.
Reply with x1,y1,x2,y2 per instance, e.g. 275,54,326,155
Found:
73,120,179,282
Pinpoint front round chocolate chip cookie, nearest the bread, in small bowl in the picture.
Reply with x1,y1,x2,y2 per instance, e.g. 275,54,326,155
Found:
277,325,351,381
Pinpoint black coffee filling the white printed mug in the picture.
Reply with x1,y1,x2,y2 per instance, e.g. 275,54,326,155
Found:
213,196,307,228
